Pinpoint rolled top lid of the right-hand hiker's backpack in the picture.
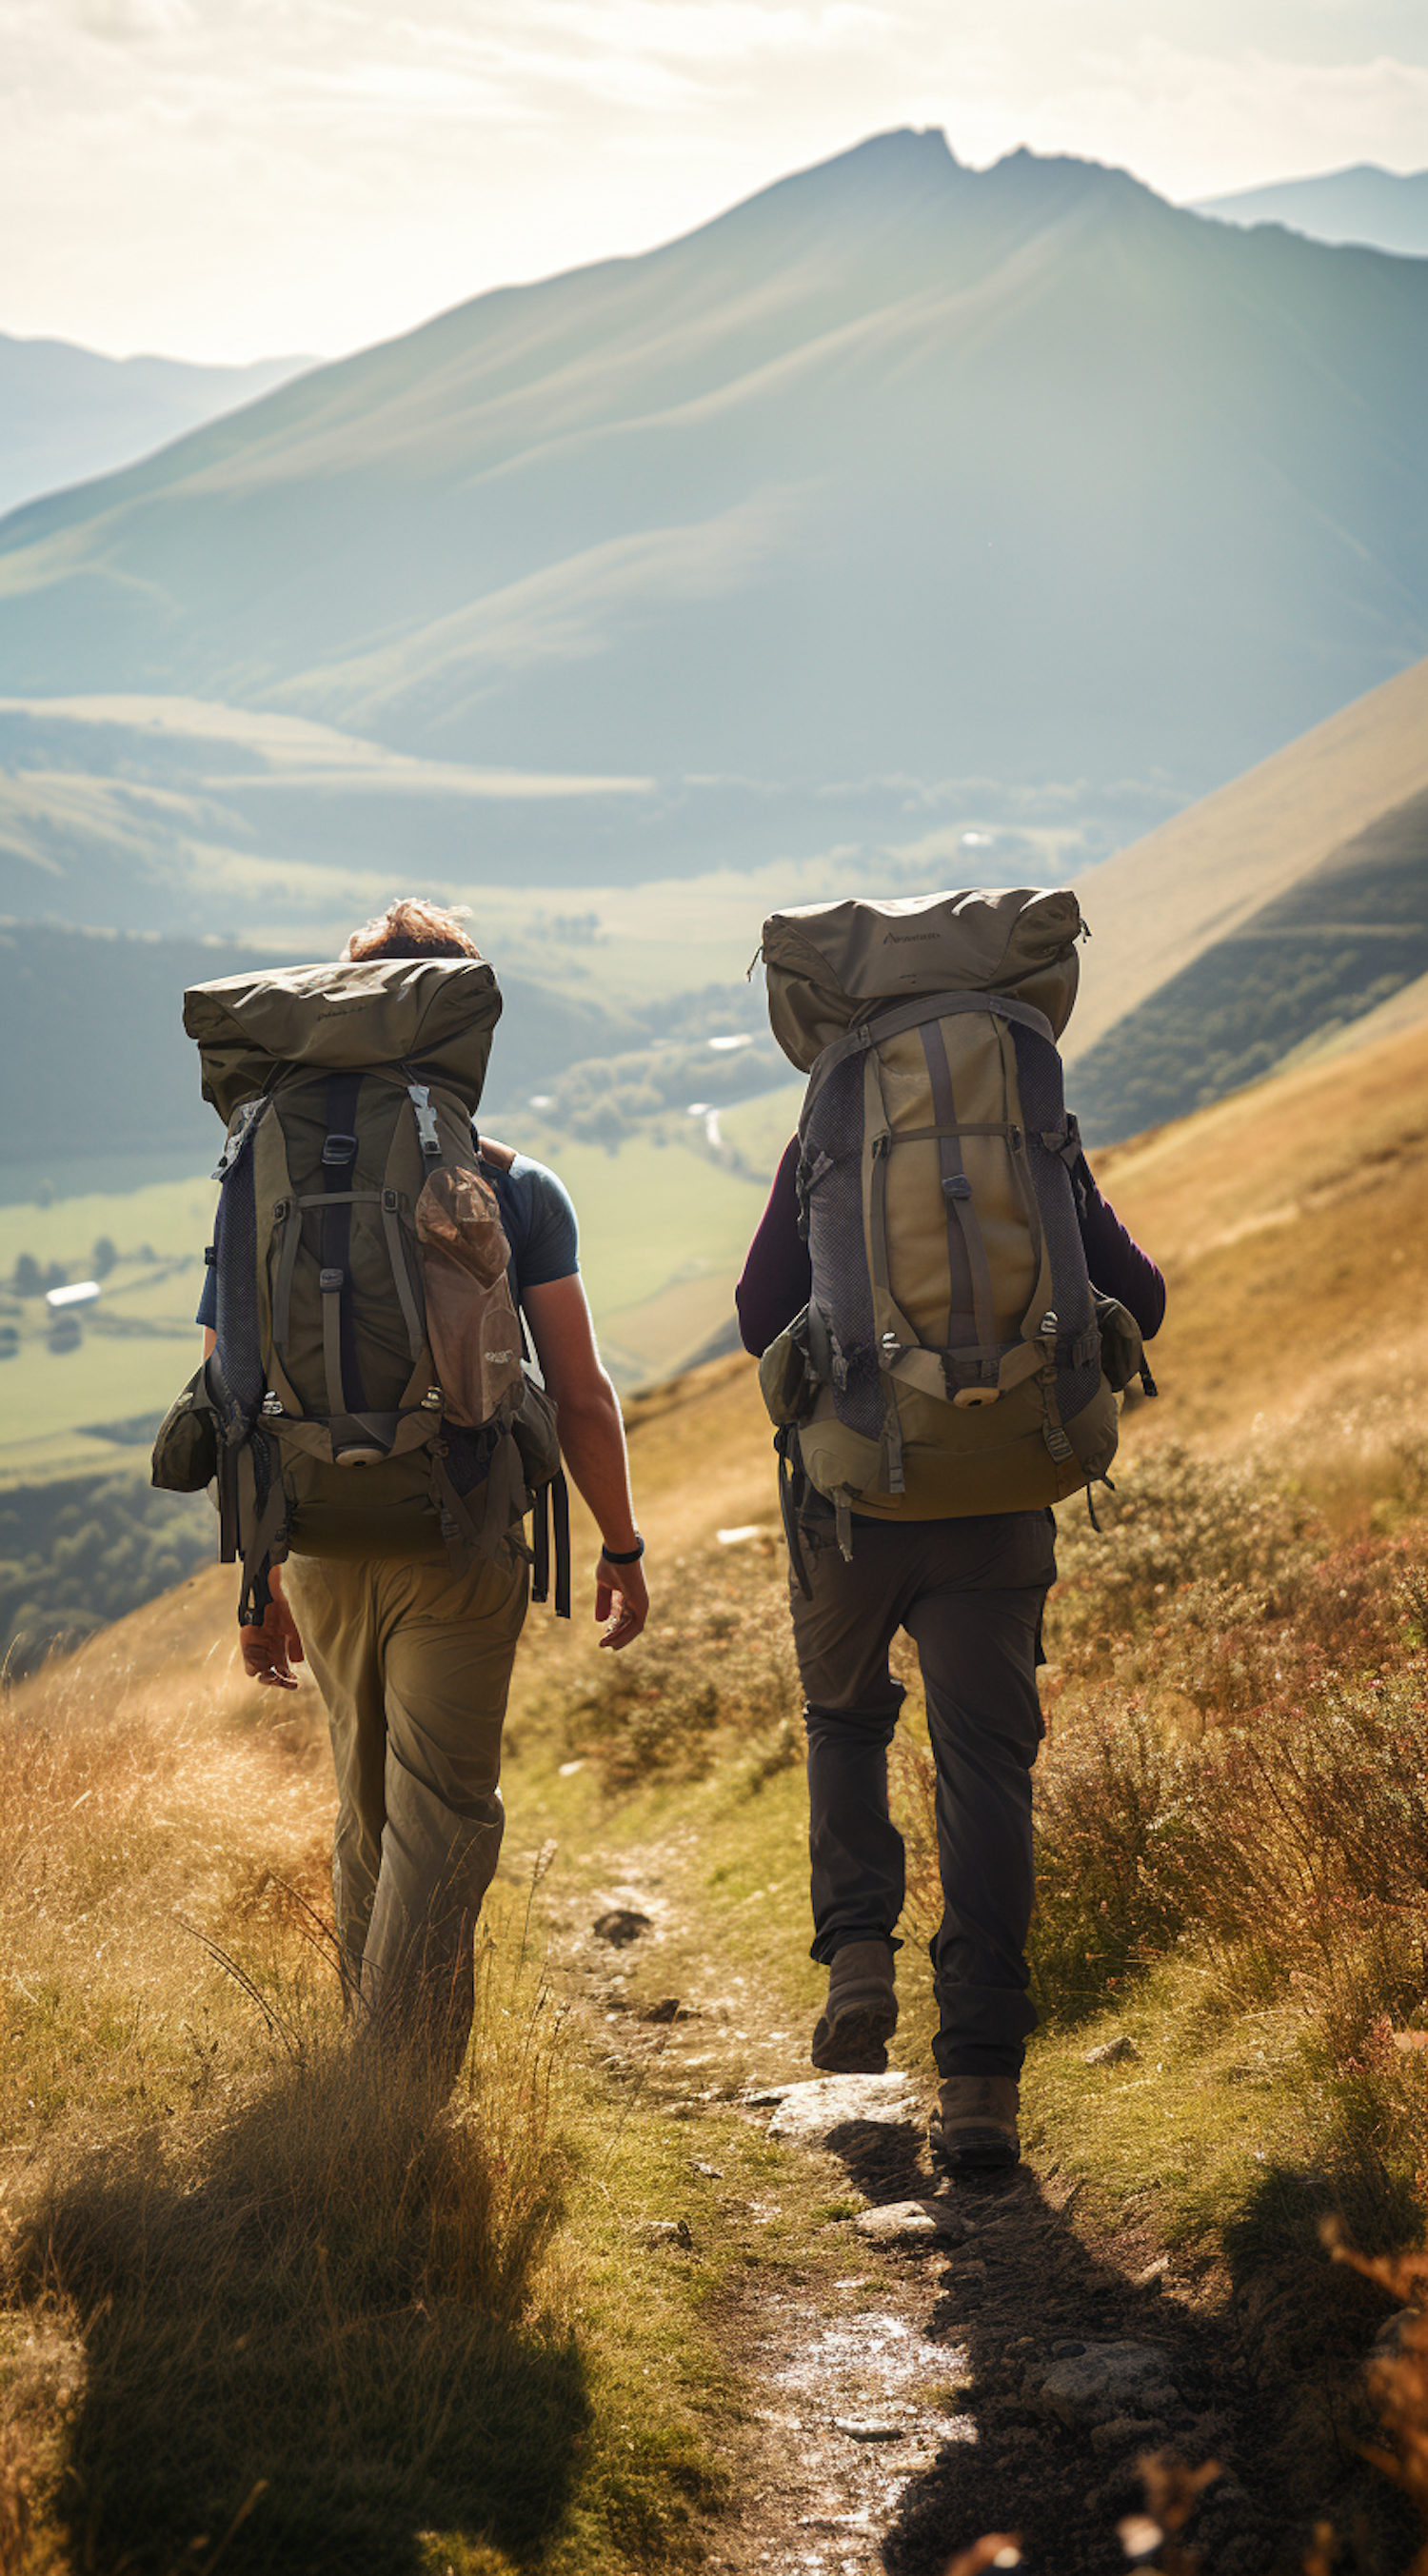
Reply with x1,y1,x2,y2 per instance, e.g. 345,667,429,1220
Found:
761,886,1085,1074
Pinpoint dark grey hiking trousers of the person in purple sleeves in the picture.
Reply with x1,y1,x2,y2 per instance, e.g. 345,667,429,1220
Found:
791,1512,1057,2076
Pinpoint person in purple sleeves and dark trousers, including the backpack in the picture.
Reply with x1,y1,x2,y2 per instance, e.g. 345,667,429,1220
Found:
737,889,1165,2171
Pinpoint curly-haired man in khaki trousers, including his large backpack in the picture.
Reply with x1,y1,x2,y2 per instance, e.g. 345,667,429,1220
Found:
167,902,649,2073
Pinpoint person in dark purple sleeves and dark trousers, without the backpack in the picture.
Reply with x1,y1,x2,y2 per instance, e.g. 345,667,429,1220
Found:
735,1118,1165,2171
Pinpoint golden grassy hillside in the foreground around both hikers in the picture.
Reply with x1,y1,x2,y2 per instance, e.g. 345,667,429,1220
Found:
0,1030,1428,2576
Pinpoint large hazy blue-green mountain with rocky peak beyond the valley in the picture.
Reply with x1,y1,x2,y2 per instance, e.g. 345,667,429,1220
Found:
0,131,1428,814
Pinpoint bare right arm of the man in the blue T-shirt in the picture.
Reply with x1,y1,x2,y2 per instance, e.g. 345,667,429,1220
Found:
524,1275,649,1649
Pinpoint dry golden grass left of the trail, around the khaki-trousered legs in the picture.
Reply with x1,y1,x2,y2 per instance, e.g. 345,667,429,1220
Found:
0,1576,590,2576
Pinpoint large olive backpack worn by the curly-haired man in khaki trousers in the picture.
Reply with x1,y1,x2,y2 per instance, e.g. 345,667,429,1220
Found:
154,959,569,1625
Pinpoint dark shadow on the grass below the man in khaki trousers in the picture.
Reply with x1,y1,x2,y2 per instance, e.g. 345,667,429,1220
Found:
15,2051,590,2576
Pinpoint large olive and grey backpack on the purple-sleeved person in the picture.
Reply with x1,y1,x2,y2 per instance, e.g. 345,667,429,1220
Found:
761,886,1141,1572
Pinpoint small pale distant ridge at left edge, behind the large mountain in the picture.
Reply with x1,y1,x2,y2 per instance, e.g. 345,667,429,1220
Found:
0,332,312,525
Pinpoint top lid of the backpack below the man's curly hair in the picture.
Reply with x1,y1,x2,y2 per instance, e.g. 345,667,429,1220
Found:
183,959,500,1118
